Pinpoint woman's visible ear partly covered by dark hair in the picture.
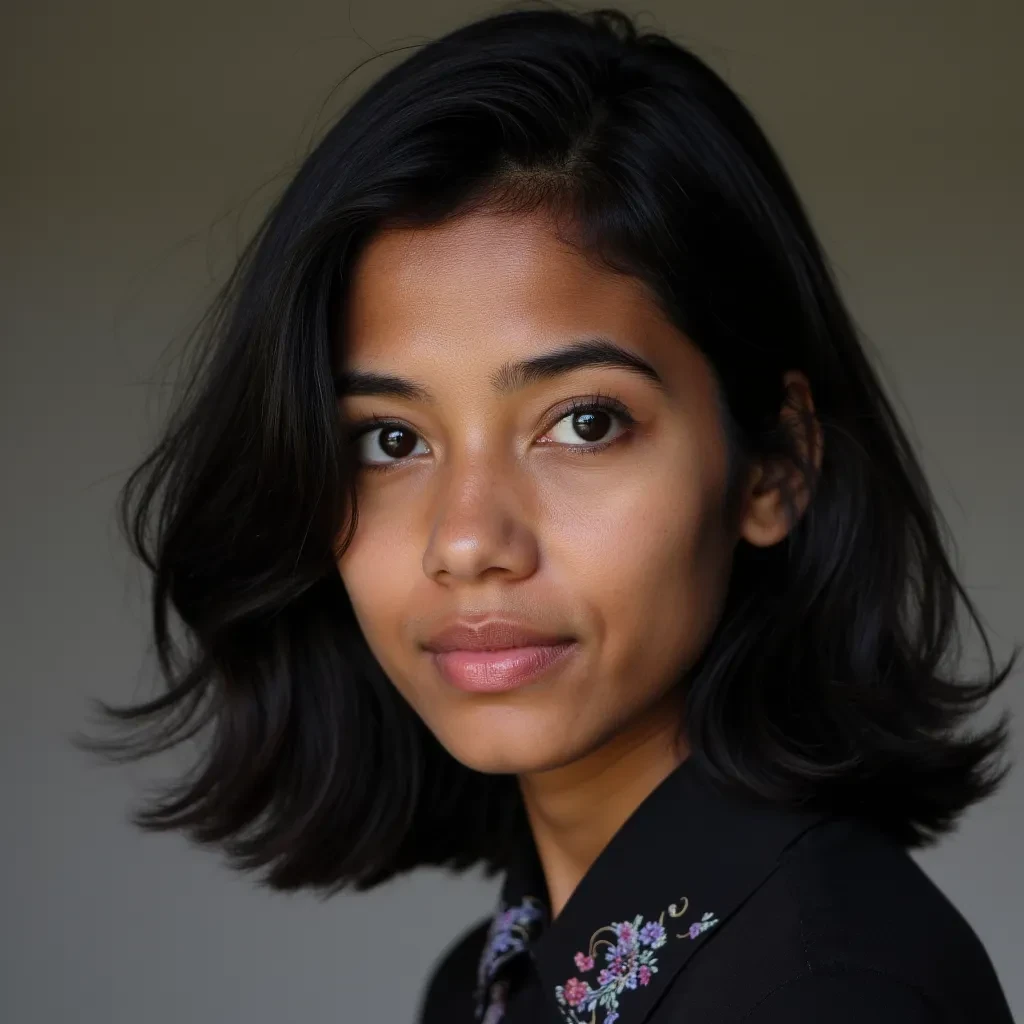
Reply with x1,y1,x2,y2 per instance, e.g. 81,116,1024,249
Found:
739,370,823,548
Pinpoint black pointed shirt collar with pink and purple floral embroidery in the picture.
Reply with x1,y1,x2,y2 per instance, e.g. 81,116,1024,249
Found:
476,757,824,1024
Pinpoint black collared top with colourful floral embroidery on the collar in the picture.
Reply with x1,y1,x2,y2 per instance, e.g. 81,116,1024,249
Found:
411,759,1012,1024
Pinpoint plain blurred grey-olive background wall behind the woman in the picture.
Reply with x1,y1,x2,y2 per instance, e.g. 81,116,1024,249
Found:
0,0,1024,1024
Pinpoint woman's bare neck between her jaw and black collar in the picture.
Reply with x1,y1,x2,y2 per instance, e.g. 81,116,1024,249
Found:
519,693,689,919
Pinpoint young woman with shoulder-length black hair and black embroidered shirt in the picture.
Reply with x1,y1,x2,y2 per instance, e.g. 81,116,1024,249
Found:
79,10,1017,1024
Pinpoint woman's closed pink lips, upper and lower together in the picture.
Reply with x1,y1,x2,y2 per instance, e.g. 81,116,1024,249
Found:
424,618,579,693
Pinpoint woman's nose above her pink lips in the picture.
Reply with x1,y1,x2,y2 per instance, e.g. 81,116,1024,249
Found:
423,459,539,584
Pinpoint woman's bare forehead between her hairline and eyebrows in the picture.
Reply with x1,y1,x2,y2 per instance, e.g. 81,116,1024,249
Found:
344,205,667,361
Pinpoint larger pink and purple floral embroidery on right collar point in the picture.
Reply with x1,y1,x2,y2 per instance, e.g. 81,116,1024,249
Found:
555,899,718,1024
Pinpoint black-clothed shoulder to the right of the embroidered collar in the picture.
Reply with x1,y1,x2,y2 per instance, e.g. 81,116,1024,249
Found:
675,818,1012,1024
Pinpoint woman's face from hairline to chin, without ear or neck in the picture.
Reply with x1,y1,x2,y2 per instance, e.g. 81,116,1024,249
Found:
338,214,753,774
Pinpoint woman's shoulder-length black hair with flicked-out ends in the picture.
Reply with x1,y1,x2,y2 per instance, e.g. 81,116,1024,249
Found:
77,8,1019,892
